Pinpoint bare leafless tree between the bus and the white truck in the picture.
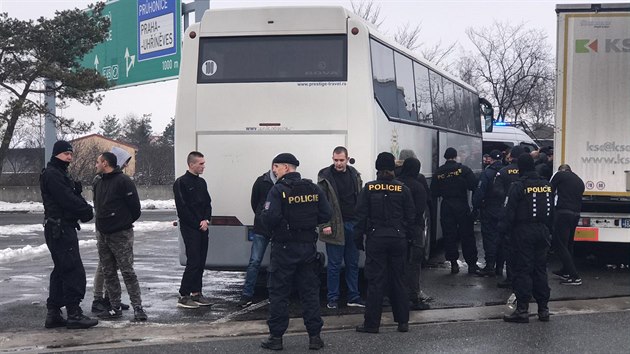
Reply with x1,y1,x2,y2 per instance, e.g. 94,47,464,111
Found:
459,22,553,122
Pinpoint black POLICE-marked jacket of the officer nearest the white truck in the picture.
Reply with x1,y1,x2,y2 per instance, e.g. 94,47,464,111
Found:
500,171,554,232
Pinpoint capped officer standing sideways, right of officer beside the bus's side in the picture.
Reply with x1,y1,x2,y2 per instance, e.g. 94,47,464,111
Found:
472,150,504,277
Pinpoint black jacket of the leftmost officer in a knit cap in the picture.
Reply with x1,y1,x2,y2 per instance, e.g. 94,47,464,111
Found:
39,156,94,224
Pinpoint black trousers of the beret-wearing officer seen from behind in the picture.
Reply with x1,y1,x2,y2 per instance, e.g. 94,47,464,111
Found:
267,241,324,337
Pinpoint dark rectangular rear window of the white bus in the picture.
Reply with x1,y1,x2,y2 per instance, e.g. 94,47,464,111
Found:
197,34,347,84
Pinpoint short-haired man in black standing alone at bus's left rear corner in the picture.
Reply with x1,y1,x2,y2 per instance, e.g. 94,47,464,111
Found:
173,151,212,309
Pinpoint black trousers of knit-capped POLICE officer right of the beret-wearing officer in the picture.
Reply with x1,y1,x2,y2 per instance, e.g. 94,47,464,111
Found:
363,237,409,329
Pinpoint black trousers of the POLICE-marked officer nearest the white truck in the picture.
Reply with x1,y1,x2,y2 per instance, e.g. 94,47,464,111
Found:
510,223,551,306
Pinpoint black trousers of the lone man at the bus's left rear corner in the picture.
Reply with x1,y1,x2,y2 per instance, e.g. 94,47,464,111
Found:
179,224,208,296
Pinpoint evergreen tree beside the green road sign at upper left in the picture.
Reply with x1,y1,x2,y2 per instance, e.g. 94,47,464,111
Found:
0,2,110,173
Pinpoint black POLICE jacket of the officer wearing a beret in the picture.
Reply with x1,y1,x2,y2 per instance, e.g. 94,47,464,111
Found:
262,172,332,242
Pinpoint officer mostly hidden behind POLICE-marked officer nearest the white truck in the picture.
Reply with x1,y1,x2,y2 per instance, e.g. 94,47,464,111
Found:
494,145,525,288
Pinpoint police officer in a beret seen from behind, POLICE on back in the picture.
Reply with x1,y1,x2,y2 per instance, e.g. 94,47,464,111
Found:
261,153,332,350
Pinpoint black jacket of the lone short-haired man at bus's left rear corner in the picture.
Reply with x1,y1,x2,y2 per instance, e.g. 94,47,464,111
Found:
173,171,212,230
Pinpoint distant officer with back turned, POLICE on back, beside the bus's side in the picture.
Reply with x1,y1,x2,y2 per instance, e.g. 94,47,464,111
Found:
431,147,478,274
